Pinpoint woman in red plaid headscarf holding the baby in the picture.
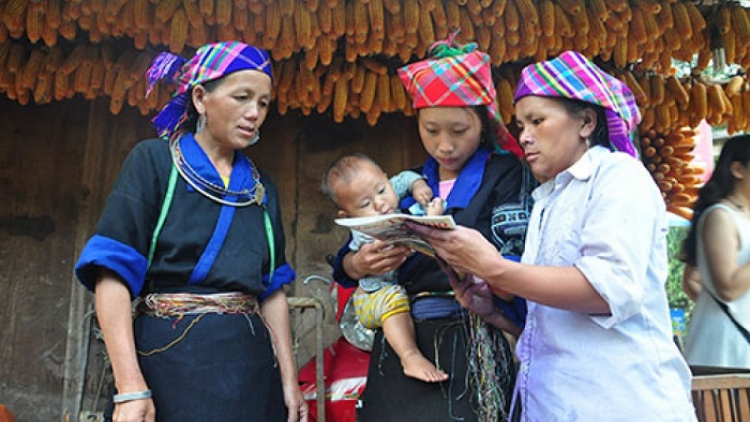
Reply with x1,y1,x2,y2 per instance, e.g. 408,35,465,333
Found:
334,35,532,422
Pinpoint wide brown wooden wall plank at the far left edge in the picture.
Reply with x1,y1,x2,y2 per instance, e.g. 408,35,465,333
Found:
0,100,88,421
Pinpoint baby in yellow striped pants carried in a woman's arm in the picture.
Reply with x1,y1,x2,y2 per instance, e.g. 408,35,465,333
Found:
322,154,448,382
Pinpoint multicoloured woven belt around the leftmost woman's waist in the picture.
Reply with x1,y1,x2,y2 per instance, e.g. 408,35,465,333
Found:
136,292,258,317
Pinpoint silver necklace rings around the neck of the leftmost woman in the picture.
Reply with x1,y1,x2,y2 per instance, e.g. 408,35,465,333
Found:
169,140,265,207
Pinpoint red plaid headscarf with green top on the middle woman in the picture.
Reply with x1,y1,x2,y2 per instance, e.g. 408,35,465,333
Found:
398,37,523,157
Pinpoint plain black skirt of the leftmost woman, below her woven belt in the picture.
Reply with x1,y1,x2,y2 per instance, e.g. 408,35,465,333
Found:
107,313,287,422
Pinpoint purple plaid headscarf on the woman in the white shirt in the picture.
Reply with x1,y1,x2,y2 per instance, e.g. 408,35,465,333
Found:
513,51,641,157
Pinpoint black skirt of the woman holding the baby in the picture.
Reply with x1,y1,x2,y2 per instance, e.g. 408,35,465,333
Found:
357,316,514,422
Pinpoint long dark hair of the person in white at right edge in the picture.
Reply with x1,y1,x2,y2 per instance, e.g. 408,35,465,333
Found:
680,135,750,265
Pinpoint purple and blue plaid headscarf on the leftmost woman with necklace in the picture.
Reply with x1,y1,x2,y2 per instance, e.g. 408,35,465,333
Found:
146,41,273,139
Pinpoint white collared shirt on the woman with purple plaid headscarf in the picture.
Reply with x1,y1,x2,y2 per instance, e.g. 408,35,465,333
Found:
516,147,695,422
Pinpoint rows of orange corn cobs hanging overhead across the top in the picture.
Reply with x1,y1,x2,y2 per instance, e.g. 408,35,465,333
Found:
0,0,750,133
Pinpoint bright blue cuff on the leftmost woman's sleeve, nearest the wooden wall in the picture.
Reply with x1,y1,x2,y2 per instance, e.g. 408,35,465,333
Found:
75,235,148,297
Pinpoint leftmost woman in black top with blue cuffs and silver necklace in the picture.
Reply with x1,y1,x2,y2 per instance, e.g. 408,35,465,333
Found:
76,42,308,422
